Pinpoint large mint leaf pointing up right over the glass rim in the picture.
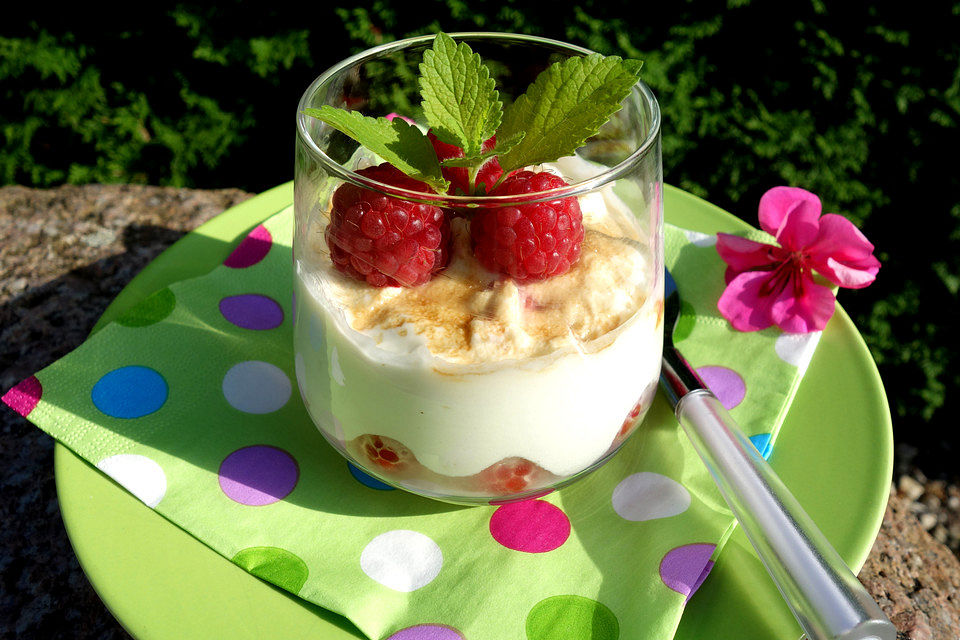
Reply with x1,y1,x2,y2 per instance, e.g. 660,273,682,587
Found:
497,53,643,174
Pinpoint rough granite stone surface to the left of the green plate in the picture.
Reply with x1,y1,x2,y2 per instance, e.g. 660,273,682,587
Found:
0,185,249,639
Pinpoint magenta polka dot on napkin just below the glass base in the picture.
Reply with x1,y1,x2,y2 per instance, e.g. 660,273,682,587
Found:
490,500,570,553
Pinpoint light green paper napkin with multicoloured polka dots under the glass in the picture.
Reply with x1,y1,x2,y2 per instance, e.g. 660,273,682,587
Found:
3,209,818,640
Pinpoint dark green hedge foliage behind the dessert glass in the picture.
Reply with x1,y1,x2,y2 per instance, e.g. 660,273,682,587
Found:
0,0,960,472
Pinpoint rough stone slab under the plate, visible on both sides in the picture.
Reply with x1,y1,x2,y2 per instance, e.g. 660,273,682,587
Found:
0,185,960,640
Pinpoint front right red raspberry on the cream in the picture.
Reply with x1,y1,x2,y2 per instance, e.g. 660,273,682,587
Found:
470,171,583,282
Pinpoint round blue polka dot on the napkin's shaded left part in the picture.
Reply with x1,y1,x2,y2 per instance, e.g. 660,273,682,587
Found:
90,365,167,418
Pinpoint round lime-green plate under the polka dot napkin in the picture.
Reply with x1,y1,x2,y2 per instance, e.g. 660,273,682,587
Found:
55,184,893,640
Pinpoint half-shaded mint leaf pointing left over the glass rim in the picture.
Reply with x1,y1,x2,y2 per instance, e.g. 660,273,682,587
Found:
304,105,450,193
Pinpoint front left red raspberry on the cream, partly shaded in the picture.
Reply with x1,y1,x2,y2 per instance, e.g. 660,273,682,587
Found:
326,163,450,287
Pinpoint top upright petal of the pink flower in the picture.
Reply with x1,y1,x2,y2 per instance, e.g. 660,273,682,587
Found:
759,187,822,251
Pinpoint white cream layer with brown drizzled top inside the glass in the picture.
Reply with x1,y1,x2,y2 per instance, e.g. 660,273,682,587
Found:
295,165,663,480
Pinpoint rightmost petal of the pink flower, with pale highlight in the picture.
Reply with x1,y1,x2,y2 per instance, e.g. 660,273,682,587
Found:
806,213,880,289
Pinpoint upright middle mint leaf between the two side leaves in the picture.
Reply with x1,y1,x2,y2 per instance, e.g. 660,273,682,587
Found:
420,33,503,157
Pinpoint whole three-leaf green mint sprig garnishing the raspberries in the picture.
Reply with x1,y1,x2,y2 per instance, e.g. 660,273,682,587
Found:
304,33,643,195
